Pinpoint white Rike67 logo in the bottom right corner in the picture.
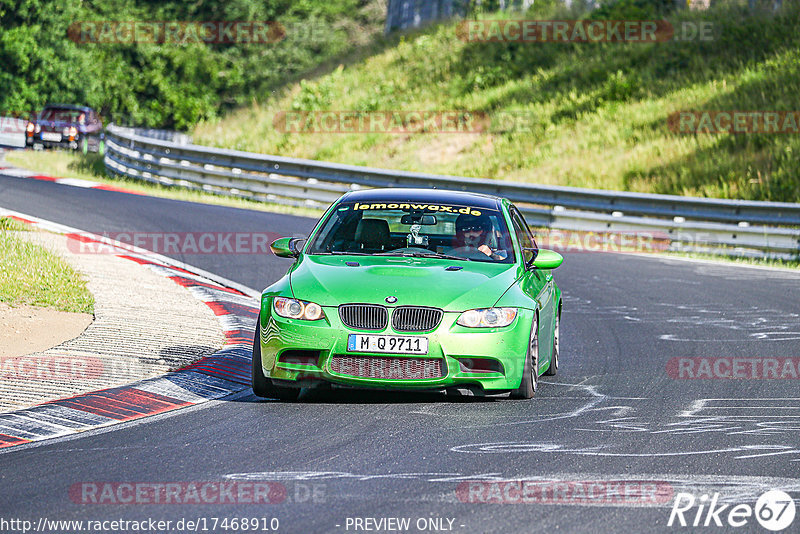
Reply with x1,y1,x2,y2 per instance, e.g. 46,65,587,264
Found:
667,490,796,532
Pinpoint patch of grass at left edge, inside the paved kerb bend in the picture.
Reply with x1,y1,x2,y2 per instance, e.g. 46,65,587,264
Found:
0,217,94,313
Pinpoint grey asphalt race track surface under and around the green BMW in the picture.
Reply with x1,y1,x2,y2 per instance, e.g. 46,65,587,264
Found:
0,177,800,533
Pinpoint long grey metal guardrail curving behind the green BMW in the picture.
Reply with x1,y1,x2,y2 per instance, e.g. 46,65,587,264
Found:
105,125,800,258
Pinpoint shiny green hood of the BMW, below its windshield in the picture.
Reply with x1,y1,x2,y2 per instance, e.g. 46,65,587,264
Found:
289,256,518,311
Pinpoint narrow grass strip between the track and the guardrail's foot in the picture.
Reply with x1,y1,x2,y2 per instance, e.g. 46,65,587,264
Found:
5,150,322,218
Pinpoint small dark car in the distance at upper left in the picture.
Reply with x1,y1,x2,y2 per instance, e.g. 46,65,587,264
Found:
25,104,105,154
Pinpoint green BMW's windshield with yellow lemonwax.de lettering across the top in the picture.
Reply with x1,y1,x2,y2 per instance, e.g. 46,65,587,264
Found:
306,201,514,263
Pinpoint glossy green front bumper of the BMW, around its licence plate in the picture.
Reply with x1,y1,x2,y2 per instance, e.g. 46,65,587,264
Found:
260,297,533,393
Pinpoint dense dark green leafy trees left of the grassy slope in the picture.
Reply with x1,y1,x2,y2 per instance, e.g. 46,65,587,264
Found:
0,0,384,129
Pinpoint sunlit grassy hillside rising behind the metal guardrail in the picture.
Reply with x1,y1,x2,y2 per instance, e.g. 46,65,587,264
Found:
194,2,800,201
